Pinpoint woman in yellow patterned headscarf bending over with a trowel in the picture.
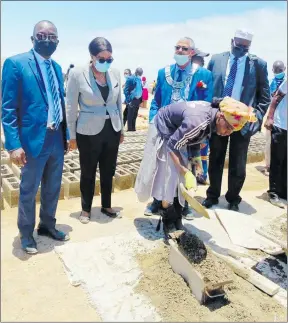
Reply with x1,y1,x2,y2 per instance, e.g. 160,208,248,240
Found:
135,97,256,237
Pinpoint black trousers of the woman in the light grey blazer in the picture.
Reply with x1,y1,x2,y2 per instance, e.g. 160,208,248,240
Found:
76,119,121,212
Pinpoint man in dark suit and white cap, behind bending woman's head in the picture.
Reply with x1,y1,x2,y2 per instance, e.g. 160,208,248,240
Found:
203,30,270,211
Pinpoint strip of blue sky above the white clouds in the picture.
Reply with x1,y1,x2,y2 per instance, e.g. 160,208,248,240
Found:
1,1,287,35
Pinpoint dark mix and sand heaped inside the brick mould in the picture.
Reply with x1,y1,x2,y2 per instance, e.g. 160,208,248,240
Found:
177,232,233,283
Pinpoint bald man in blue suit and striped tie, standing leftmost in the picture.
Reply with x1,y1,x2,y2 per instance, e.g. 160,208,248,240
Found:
2,21,69,254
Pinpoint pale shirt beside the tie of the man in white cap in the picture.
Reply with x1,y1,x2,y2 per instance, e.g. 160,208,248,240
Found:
224,53,247,101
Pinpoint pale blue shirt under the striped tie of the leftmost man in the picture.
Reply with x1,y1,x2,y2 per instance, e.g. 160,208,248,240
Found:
33,49,63,127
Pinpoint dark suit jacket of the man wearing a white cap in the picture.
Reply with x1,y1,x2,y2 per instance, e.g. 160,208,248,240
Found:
207,52,270,136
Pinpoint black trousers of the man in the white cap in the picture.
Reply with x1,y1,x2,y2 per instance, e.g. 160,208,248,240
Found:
206,131,250,204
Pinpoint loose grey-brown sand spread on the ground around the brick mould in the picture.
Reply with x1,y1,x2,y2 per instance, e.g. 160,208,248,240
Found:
134,246,287,322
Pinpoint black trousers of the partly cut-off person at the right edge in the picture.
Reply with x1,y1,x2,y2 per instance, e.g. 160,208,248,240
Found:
268,126,287,200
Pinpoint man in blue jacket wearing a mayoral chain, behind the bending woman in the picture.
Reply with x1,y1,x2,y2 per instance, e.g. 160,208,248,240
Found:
144,37,213,219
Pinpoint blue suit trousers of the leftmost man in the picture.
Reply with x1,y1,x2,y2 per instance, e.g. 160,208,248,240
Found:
17,125,65,253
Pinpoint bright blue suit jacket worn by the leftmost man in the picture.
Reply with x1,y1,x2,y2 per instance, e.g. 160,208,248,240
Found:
2,50,69,157
